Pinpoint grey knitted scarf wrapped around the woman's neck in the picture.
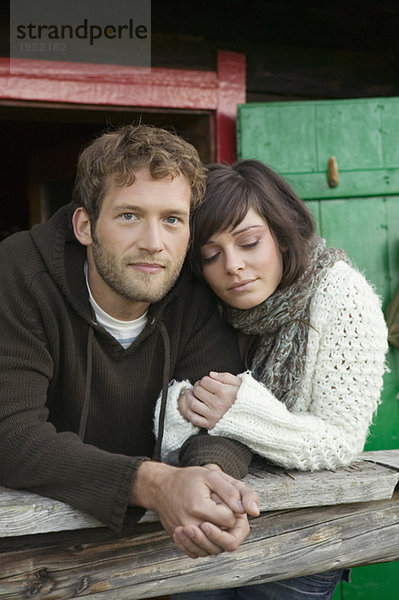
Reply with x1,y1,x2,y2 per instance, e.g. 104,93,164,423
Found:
226,236,350,409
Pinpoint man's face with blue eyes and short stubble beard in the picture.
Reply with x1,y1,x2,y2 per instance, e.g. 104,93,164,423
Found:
83,169,191,320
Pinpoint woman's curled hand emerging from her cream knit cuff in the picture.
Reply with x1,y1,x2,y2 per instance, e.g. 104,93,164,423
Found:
178,371,241,429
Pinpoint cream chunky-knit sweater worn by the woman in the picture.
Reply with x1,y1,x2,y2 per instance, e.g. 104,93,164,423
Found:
155,261,387,470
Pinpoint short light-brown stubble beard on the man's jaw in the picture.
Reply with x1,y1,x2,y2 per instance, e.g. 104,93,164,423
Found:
91,239,185,304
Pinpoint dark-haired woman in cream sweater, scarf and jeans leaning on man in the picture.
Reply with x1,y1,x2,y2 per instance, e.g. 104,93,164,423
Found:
155,160,387,600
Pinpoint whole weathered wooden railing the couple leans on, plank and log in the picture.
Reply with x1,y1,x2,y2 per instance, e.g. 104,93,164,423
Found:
0,450,399,600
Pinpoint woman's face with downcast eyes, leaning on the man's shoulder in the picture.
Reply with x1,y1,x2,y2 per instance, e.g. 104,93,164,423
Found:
201,208,283,309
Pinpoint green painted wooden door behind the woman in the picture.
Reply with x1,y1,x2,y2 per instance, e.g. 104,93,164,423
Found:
237,98,399,600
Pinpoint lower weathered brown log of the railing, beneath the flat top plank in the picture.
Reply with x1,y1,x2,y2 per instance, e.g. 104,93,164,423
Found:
0,493,399,600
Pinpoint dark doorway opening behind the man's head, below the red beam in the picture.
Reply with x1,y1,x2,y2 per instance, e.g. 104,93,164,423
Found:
0,101,215,239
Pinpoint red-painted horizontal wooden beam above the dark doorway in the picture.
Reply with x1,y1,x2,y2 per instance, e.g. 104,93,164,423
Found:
0,57,218,110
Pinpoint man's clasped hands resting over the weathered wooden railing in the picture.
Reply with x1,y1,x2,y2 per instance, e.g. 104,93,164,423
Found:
130,461,259,558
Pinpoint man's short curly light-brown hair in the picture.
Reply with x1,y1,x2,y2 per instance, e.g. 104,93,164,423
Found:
72,125,205,227
